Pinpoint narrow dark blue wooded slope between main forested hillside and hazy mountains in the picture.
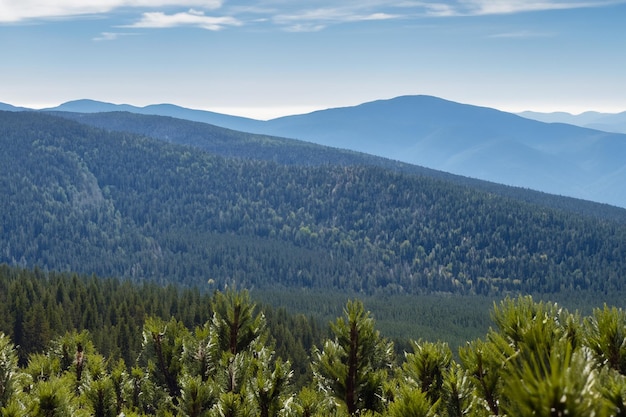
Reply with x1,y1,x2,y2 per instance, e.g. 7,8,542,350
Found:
54,112,626,221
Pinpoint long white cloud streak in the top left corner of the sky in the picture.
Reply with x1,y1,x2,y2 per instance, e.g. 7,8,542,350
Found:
0,0,222,23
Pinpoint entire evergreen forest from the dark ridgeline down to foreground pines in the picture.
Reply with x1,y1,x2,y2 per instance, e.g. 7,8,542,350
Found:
0,111,626,417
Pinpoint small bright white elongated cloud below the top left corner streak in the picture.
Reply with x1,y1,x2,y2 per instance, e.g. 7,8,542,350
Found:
126,9,242,30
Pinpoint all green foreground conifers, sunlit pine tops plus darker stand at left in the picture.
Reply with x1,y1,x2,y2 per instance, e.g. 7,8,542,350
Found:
0,266,626,417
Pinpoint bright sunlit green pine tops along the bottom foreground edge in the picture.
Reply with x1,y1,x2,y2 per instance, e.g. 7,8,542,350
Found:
0,284,626,417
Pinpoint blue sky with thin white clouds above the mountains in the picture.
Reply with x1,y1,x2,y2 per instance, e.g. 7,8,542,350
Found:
0,0,626,119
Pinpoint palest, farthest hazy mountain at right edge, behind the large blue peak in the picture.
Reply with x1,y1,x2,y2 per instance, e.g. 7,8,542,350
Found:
518,111,626,133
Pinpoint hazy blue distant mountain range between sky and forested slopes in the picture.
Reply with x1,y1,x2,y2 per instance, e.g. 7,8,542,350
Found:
4,96,626,207
